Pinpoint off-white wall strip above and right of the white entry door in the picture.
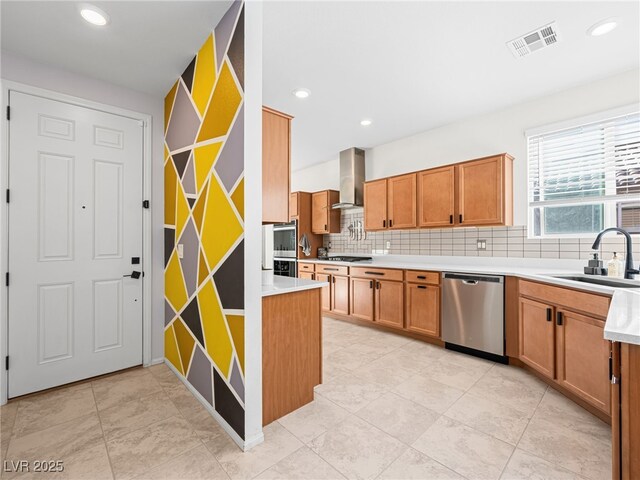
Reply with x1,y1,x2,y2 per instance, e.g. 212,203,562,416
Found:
0,52,164,361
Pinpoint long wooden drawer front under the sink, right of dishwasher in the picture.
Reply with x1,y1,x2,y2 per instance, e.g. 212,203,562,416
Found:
519,280,611,318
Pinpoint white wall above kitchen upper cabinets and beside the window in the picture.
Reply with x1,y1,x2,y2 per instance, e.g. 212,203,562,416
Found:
291,70,640,225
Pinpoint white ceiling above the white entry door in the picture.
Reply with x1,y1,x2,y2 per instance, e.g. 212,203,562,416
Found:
0,0,231,97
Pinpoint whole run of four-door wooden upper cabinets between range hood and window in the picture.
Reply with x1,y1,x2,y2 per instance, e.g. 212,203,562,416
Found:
364,153,513,231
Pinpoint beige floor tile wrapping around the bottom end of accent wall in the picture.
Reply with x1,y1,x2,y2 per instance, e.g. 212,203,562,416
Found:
206,422,302,479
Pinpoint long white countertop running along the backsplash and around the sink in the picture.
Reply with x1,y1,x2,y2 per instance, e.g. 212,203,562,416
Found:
301,254,640,345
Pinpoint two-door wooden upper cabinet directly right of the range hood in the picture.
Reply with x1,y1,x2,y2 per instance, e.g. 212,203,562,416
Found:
364,173,416,230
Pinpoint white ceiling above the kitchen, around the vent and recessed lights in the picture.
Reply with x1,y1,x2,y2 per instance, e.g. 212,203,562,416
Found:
263,1,640,170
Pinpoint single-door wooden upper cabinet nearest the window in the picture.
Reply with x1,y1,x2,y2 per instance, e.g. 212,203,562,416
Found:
454,154,513,226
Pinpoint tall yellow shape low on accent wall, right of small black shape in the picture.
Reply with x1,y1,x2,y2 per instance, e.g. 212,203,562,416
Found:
198,280,233,377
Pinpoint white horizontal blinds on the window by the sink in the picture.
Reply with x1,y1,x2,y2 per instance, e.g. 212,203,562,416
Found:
528,112,640,207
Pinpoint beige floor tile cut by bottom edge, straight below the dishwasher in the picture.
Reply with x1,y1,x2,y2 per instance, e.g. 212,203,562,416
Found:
413,417,514,479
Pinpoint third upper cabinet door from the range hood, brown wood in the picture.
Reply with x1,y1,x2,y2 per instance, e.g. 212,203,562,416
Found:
418,166,456,227
